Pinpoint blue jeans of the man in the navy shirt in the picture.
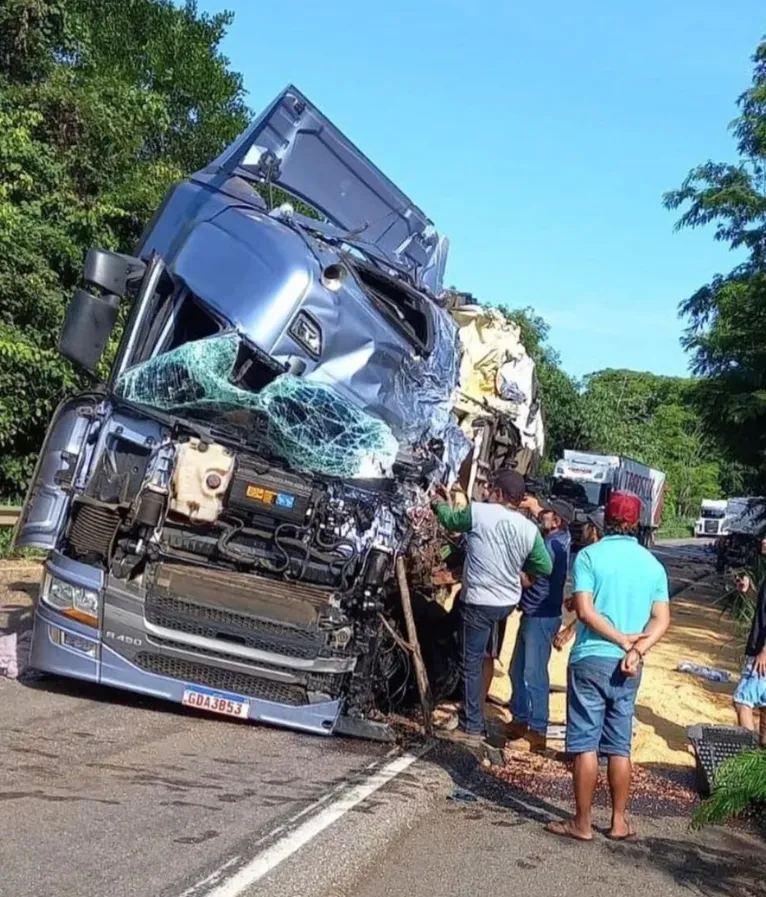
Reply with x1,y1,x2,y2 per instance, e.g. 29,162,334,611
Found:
511,616,561,735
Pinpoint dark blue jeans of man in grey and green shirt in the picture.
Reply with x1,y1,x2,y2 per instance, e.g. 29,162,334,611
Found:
459,603,513,735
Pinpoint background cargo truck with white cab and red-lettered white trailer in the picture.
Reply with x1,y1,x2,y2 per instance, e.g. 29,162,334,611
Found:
551,449,665,546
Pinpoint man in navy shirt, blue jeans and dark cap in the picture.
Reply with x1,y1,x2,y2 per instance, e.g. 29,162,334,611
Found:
507,500,574,751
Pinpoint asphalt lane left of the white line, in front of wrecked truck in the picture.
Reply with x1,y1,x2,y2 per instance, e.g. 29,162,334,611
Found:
0,680,396,897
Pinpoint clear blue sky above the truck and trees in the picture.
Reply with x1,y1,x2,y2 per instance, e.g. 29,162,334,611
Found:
199,0,766,376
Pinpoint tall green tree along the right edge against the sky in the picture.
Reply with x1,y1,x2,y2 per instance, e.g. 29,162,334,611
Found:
664,40,766,487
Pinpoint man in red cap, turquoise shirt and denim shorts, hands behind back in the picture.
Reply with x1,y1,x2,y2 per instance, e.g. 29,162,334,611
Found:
548,492,670,841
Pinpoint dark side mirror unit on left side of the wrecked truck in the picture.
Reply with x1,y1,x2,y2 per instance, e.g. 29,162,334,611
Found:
59,249,146,373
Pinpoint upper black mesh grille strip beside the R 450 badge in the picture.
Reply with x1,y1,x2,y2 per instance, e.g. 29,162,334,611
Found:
144,594,325,660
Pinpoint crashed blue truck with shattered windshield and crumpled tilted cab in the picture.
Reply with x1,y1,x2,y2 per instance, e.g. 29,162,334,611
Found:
15,87,543,737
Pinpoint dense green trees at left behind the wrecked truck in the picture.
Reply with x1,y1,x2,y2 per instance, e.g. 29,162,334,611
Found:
0,0,248,499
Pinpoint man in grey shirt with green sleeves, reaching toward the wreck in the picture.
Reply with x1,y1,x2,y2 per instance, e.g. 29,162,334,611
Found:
435,469,552,746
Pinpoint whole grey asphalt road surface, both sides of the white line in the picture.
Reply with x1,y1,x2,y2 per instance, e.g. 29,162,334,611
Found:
0,546,752,897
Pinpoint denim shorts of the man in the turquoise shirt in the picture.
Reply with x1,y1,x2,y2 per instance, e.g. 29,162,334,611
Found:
566,657,641,757
